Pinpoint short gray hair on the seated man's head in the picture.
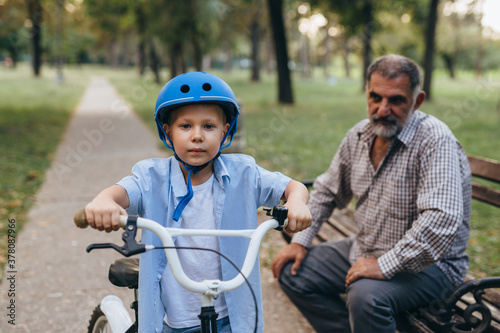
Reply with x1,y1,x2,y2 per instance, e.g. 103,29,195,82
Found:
366,54,422,93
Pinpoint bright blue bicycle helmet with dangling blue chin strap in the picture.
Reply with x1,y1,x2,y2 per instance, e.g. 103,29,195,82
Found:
155,72,239,221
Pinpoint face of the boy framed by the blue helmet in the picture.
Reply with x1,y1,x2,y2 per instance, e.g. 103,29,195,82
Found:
163,104,229,166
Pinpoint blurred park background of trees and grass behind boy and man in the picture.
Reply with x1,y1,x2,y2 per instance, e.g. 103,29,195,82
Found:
0,0,500,277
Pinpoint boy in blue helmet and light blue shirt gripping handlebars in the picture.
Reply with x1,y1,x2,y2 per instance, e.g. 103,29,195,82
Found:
86,72,311,333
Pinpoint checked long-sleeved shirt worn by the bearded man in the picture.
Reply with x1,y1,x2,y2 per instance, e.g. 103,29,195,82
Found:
293,111,471,284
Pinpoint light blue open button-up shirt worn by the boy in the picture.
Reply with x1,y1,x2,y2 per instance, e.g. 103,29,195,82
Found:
118,154,290,333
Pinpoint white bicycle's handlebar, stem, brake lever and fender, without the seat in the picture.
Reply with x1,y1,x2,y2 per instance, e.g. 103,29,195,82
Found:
74,206,287,333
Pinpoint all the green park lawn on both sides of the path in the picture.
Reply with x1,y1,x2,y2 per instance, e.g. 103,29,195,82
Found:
0,63,500,277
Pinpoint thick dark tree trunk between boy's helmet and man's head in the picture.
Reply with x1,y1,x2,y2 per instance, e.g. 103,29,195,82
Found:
267,0,293,104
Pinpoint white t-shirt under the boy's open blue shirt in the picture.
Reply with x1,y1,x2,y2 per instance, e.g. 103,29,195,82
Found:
161,175,228,328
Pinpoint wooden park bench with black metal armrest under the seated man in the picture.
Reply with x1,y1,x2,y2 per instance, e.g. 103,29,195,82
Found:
283,156,500,333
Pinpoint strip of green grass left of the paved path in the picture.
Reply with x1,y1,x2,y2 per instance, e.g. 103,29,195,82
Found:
0,65,87,277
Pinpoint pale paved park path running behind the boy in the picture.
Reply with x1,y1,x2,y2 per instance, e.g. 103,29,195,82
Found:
0,78,310,333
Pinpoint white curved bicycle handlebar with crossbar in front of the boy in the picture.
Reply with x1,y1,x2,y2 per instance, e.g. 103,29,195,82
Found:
120,216,279,297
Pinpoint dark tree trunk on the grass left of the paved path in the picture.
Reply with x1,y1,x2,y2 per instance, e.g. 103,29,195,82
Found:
26,0,42,77
